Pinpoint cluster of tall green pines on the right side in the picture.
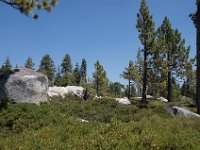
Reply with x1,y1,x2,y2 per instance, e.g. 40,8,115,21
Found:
122,0,196,103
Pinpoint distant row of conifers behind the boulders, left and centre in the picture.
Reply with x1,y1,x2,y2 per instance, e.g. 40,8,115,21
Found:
0,54,136,97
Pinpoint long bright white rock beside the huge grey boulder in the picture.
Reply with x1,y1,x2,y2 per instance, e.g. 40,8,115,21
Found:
48,86,84,98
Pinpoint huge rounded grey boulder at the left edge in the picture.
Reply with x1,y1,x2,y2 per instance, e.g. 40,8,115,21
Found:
0,68,48,104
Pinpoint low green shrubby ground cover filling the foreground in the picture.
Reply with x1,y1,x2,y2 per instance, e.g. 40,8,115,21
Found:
0,97,200,150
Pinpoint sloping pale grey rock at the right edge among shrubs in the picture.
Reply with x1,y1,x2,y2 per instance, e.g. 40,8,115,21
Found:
168,106,200,118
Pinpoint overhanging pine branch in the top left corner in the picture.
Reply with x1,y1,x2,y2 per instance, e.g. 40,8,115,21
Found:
0,0,57,19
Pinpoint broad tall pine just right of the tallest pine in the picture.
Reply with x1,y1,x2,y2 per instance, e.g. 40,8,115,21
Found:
154,17,190,102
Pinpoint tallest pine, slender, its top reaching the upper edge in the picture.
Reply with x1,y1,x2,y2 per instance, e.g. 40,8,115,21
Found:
136,0,155,103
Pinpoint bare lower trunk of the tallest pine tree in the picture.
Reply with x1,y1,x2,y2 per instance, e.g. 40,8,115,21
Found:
142,46,147,103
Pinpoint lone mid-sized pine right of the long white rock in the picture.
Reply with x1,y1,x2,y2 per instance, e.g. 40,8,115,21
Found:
93,60,108,96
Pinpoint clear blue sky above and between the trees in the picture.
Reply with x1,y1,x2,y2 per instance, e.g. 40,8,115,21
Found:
0,0,196,84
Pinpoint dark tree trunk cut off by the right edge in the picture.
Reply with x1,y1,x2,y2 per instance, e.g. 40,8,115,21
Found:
196,2,200,114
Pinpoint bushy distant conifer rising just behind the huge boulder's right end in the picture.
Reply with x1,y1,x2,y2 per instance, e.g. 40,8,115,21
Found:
38,54,56,85
